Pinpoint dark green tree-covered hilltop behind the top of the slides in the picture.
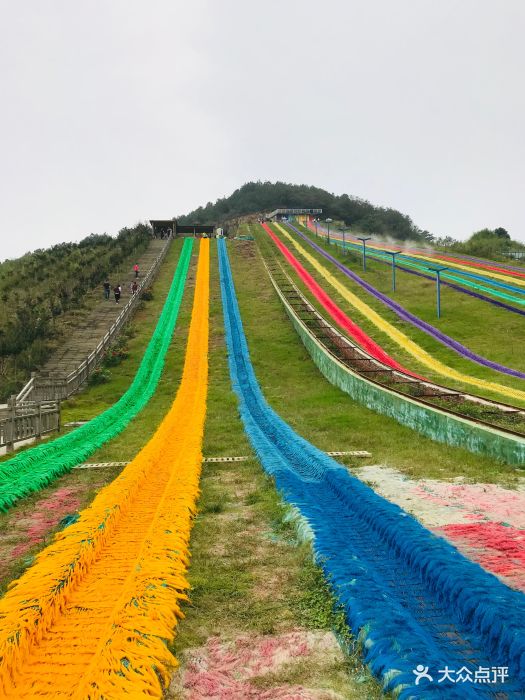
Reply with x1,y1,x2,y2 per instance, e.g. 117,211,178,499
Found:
179,182,432,241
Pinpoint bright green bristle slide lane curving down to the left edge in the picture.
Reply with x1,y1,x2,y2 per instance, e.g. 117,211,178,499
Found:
0,238,193,511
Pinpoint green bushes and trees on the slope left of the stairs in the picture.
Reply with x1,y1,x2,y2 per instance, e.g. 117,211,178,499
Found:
0,224,151,401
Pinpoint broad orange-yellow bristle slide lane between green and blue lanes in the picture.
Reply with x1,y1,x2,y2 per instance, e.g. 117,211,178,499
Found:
0,240,210,700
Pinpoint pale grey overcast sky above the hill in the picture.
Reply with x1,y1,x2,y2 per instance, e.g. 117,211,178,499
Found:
0,0,525,260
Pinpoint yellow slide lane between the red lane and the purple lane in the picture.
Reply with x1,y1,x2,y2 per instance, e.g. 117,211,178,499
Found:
275,224,525,401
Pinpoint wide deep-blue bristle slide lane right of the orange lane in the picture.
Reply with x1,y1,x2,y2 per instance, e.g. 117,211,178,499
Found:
218,240,525,700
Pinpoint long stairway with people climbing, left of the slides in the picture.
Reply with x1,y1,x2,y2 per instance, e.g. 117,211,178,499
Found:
40,239,166,375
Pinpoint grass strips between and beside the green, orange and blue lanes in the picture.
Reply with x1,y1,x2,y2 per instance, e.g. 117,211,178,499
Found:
0,241,518,700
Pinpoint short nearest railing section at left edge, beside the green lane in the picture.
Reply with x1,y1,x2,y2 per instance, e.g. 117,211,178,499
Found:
0,396,60,452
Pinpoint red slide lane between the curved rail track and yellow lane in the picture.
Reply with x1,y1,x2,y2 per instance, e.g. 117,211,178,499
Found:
261,224,423,379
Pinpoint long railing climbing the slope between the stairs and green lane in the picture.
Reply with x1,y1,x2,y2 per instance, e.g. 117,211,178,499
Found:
16,239,171,401
